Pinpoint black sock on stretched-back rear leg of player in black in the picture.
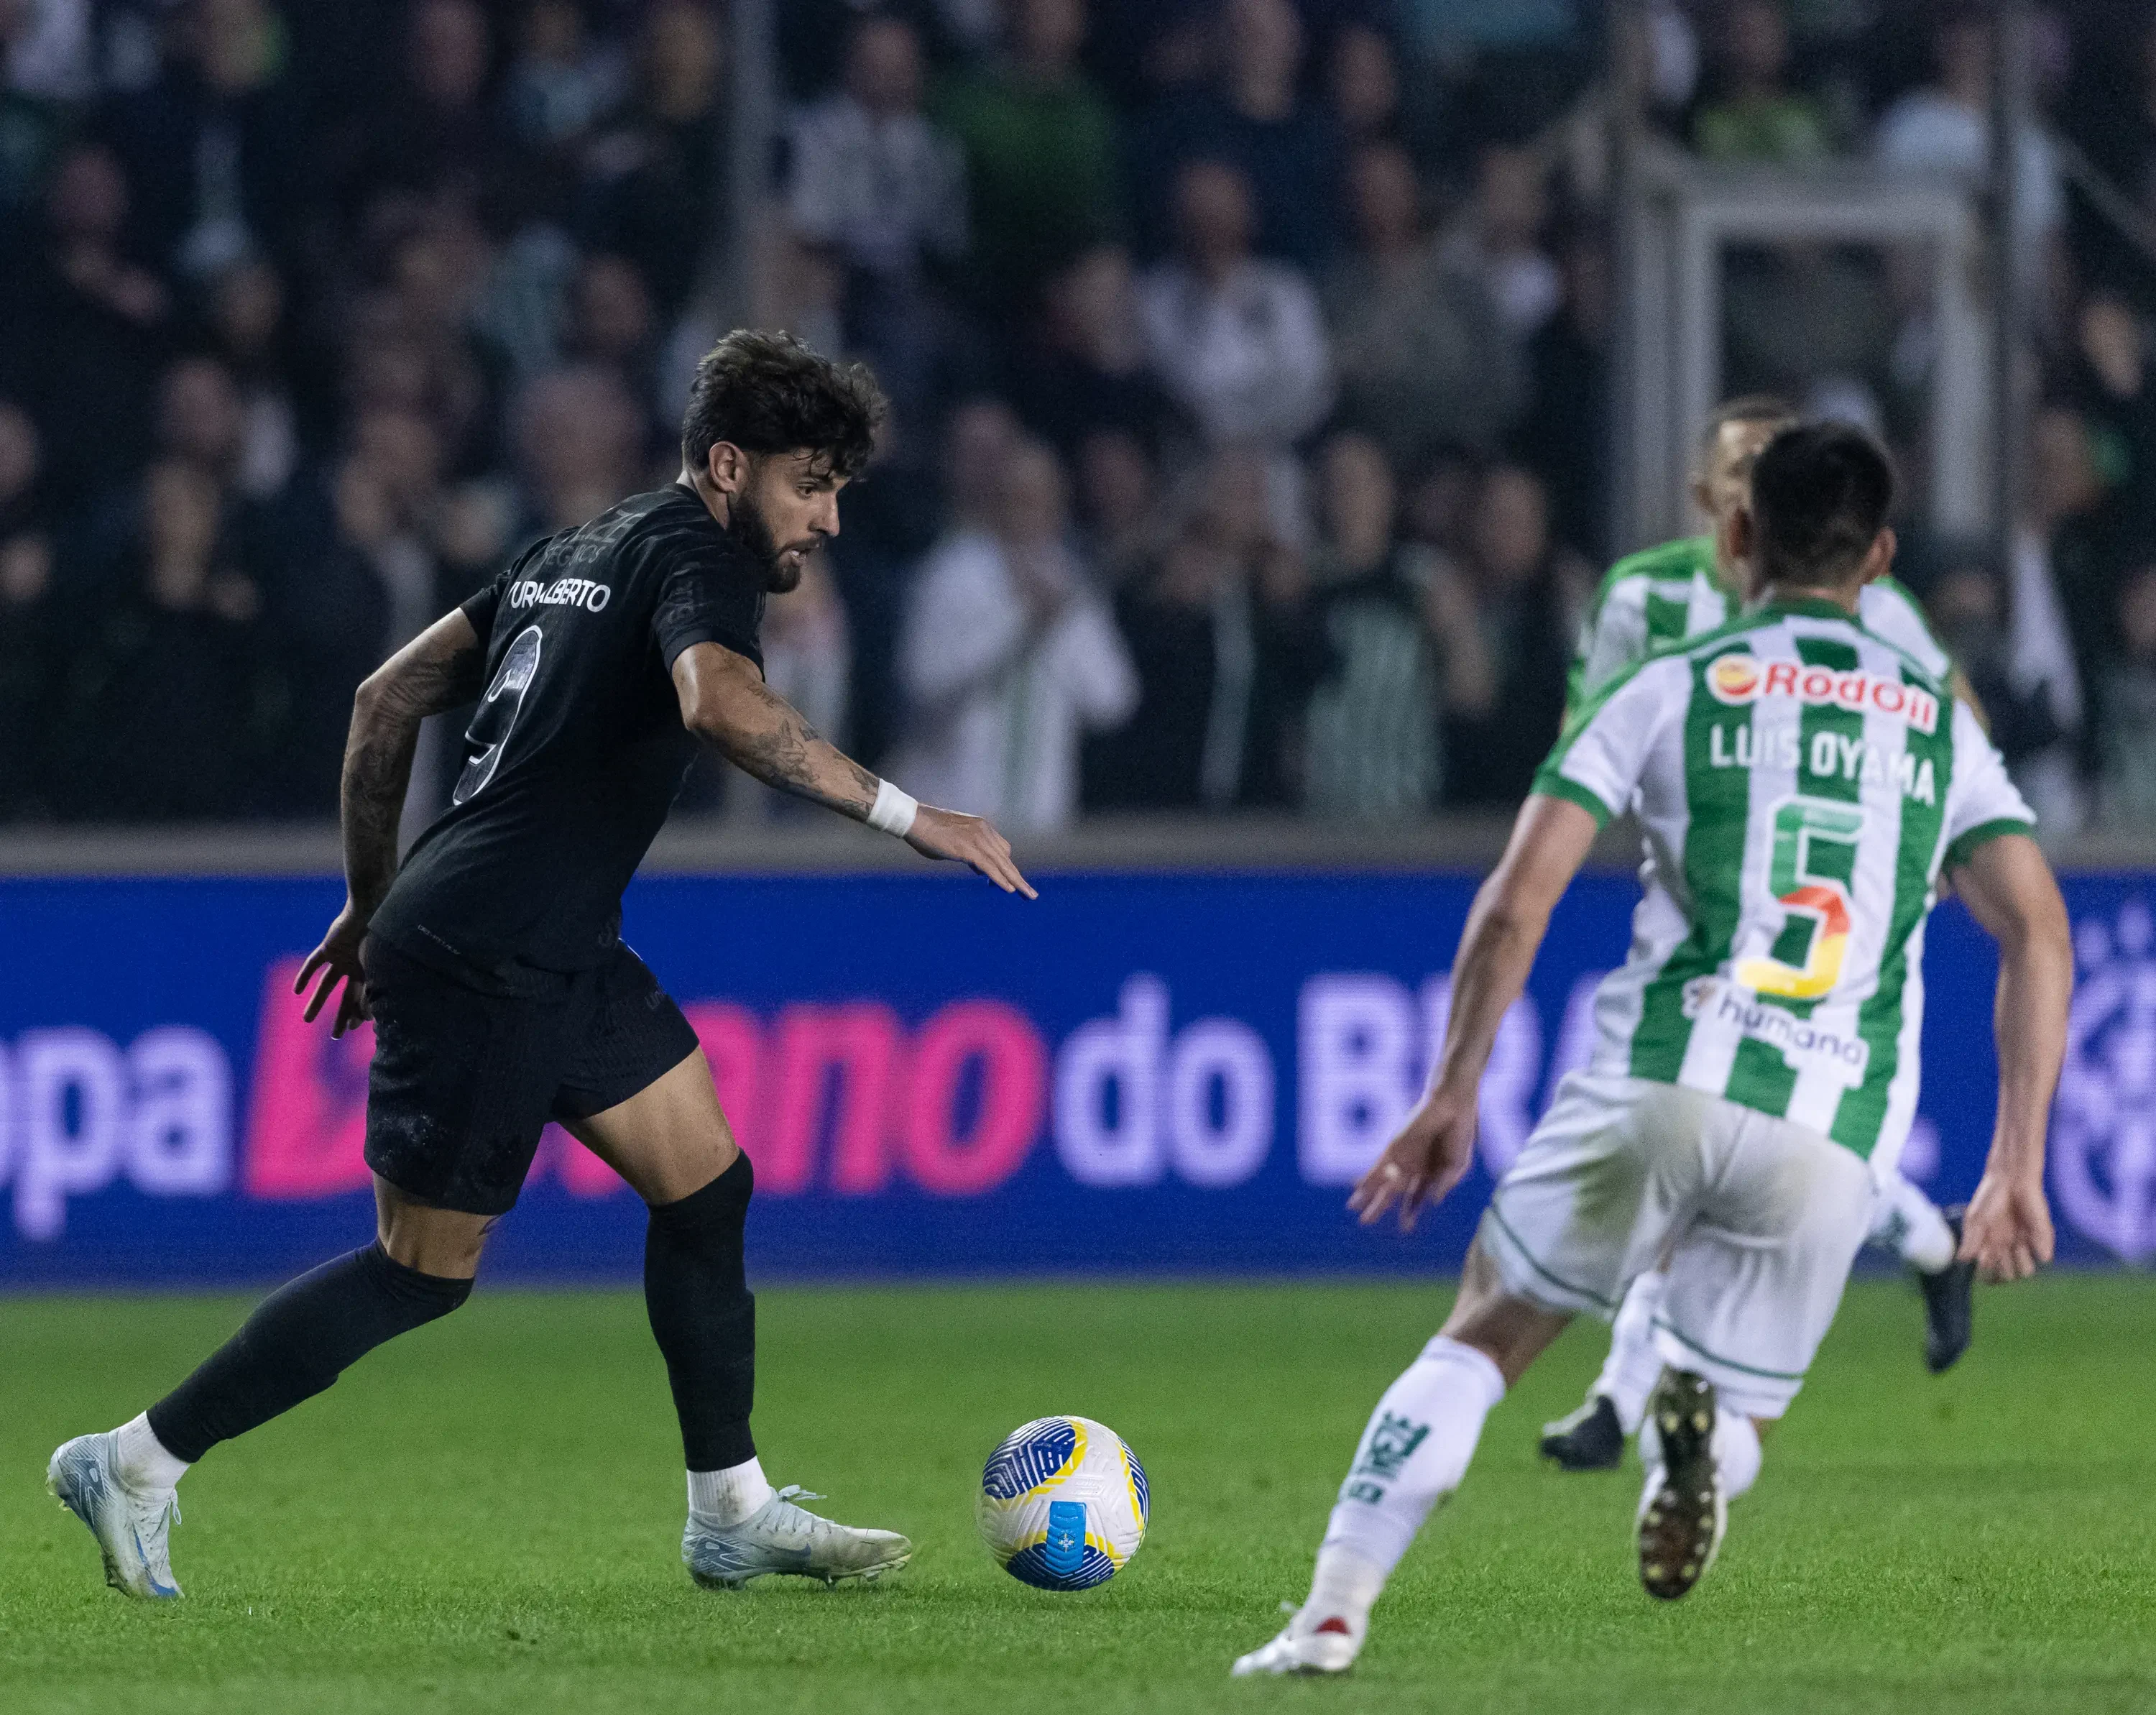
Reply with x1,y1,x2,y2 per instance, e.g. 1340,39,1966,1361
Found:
149,1241,472,1465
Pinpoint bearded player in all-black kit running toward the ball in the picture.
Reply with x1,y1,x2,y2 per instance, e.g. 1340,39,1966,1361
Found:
47,332,1033,1599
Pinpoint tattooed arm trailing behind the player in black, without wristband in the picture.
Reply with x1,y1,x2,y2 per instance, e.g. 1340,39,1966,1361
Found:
293,608,487,1036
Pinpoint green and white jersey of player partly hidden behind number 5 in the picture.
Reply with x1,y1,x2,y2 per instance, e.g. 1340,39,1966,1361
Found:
1565,535,1953,714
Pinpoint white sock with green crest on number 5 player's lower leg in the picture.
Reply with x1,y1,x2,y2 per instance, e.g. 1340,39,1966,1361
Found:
1304,1333,1505,1637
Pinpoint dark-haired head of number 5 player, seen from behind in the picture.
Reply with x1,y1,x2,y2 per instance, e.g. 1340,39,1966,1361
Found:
1751,423,1895,584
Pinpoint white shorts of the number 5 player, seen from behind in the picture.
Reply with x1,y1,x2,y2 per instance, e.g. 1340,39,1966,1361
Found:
1481,1072,1874,1417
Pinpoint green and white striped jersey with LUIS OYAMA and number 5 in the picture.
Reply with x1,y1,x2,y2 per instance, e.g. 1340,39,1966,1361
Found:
1535,599,2035,1167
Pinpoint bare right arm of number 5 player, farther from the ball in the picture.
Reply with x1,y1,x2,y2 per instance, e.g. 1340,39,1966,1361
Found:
1953,832,2074,1279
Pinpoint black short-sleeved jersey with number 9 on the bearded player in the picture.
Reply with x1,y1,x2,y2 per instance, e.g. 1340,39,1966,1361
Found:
371,485,765,986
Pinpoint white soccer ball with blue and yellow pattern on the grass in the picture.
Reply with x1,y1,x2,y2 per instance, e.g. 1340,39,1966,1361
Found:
975,1417,1151,1590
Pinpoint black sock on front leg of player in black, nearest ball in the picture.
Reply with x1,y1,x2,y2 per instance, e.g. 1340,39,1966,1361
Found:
645,1157,757,1471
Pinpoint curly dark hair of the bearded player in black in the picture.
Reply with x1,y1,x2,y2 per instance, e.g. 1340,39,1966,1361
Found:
681,328,886,477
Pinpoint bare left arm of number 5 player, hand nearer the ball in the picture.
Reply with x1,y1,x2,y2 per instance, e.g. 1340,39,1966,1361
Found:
1348,791,1598,1228
